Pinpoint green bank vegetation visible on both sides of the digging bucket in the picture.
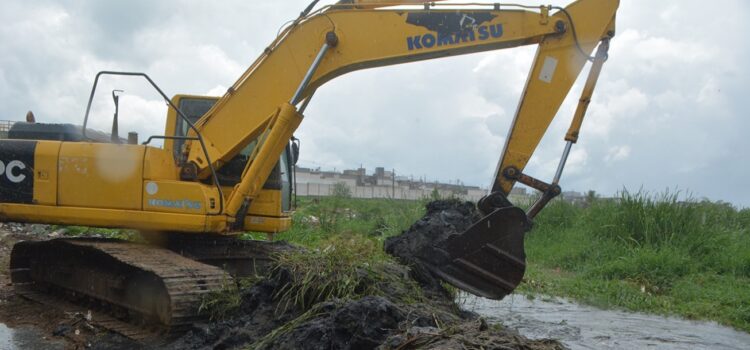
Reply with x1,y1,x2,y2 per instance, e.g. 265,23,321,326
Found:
268,192,750,331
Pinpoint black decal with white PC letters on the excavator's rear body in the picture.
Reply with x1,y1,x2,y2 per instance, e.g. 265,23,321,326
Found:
0,140,36,204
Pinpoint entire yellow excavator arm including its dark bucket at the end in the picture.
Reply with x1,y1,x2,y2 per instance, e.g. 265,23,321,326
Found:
175,0,618,299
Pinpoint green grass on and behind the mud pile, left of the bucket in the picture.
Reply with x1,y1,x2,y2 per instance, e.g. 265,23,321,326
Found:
202,195,424,319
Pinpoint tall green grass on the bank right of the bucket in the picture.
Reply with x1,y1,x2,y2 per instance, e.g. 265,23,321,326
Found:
525,191,750,330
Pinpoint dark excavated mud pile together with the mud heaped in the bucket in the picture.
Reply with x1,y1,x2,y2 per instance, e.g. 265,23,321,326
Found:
142,201,563,349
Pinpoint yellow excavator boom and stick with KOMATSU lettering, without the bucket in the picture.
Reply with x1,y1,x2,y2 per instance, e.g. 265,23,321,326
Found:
183,0,619,227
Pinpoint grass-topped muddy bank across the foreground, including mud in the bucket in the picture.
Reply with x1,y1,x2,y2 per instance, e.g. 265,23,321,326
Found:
0,202,563,349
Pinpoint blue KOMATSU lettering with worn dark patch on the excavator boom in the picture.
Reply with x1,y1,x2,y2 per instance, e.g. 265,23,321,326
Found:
406,12,503,51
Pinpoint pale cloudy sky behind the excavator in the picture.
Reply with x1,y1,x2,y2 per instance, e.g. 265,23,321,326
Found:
0,0,750,207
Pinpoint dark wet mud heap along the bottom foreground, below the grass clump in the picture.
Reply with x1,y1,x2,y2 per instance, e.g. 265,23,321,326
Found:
154,267,564,350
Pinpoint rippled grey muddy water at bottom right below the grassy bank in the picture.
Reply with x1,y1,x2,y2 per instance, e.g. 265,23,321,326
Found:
464,294,750,349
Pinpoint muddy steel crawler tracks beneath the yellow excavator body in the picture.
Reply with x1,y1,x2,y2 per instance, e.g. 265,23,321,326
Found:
10,234,294,328
